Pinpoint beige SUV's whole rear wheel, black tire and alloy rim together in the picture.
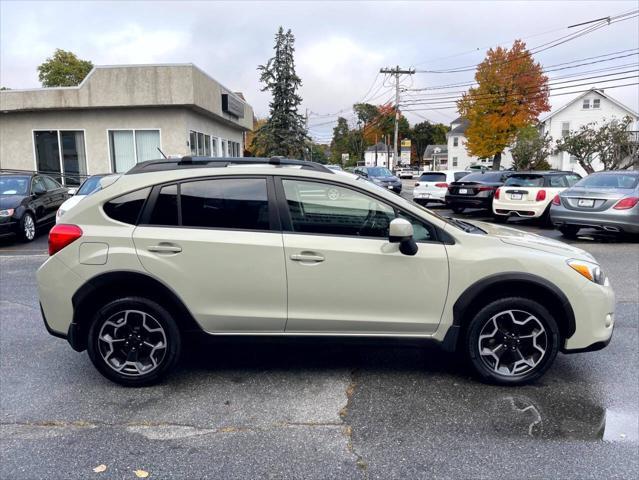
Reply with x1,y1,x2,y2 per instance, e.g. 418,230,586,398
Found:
87,297,181,387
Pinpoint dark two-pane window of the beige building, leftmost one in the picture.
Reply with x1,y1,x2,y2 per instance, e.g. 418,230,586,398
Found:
33,130,87,185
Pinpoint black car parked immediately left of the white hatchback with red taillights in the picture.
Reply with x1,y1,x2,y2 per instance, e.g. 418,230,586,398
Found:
446,171,513,213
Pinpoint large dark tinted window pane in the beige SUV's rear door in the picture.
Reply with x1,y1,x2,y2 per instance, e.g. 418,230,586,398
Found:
180,178,270,230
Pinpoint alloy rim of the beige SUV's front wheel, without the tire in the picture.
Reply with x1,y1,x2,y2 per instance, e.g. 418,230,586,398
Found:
478,310,549,377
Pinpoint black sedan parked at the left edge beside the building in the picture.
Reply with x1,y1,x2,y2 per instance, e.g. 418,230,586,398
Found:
0,172,69,242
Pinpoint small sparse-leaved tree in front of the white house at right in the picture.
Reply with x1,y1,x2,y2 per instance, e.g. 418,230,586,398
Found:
557,117,639,173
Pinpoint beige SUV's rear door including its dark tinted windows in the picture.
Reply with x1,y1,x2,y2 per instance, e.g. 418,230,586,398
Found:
133,176,286,333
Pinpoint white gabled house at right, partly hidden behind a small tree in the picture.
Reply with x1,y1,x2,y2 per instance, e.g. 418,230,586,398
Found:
541,88,639,175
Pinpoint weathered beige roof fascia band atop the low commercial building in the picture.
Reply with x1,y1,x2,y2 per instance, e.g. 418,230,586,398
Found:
0,63,253,130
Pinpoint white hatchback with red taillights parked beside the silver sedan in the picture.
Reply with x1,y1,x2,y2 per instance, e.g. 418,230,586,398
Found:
493,171,581,223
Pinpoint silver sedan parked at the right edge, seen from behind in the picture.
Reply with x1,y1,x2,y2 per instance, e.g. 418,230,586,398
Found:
550,171,639,238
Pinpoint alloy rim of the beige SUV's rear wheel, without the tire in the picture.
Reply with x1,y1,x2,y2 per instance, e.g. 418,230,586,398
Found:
98,310,167,376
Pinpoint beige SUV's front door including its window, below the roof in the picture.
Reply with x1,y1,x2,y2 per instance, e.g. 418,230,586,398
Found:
278,179,448,335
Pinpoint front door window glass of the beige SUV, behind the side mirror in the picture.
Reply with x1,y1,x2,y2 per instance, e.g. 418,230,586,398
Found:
282,180,395,238
